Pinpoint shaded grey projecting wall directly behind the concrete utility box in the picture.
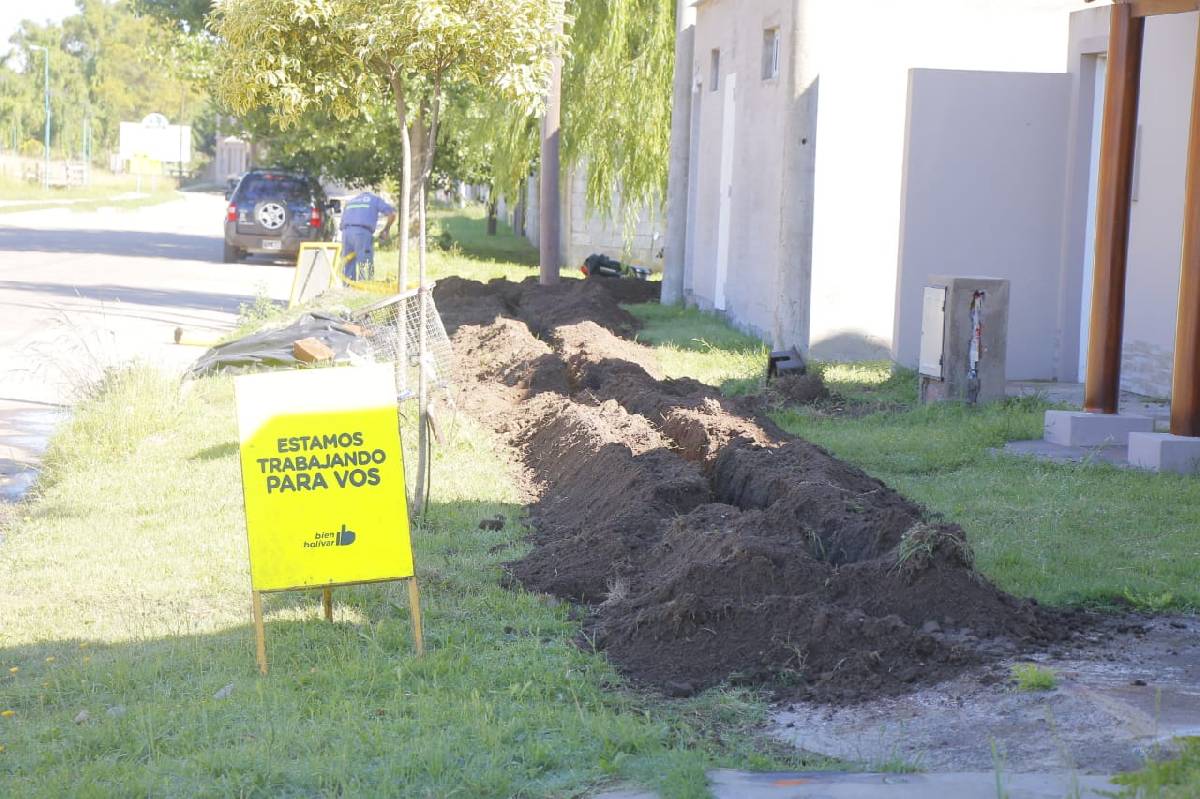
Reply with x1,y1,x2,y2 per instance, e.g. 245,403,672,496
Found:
894,70,1072,379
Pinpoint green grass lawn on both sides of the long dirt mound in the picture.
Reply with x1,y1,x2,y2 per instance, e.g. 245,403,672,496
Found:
0,211,1200,798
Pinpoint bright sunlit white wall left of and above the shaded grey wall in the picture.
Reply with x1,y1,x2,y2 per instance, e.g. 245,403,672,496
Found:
811,0,1086,358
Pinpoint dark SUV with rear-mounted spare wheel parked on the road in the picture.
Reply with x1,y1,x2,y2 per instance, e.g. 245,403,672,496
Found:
224,169,338,264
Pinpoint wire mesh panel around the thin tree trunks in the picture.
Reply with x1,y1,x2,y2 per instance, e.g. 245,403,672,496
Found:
354,287,454,402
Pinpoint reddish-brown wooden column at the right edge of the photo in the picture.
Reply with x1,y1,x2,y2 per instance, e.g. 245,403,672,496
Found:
1171,21,1200,437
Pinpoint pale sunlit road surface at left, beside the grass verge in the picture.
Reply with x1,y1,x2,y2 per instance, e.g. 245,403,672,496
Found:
0,189,292,499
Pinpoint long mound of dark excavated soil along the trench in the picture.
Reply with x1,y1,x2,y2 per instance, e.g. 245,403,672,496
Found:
434,278,1080,702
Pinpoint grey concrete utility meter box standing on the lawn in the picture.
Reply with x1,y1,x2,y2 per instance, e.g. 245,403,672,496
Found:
918,275,1008,404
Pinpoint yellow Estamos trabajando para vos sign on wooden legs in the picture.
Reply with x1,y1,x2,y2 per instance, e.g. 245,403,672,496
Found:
235,365,424,674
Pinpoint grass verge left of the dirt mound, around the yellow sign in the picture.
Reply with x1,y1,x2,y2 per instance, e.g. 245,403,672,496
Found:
0,370,812,797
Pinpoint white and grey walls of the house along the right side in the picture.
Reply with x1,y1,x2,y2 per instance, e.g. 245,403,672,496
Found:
685,0,1200,396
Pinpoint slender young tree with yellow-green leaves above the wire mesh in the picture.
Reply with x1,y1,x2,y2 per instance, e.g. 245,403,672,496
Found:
210,0,559,283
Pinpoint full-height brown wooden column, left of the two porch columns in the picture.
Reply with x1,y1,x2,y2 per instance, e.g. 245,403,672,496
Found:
1084,4,1146,414
